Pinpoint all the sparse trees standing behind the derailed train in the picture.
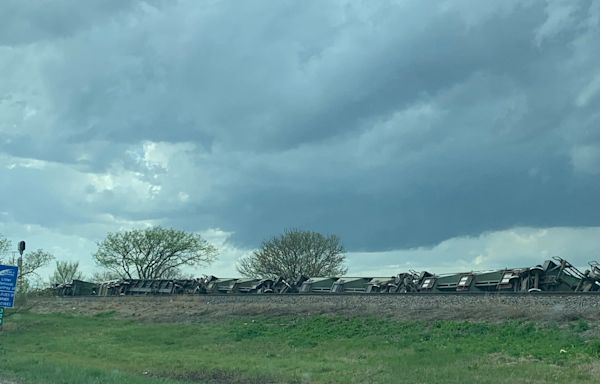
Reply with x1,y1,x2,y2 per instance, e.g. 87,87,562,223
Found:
0,226,347,290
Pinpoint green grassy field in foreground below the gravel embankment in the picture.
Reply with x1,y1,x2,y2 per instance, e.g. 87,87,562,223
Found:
0,312,600,384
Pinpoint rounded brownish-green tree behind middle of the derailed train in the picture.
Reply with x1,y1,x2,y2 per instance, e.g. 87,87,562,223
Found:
237,230,347,279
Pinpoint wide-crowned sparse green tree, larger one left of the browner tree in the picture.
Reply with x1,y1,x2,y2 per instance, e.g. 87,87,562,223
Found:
94,227,217,279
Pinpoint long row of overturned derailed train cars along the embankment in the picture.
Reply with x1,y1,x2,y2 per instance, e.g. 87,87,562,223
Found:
55,257,600,296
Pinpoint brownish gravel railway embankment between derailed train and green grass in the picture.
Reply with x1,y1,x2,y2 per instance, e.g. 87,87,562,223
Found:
21,295,600,322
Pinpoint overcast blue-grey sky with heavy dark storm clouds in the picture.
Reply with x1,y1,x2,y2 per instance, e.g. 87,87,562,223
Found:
0,0,600,276
